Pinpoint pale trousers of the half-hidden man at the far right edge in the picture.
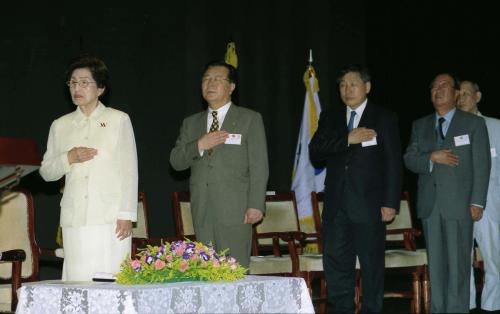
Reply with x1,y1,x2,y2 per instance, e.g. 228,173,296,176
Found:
470,215,500,311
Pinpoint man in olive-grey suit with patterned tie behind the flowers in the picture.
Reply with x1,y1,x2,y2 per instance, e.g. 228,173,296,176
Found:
170,61,269,267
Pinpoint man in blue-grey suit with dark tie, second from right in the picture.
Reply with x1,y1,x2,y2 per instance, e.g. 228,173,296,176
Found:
404,73,490,313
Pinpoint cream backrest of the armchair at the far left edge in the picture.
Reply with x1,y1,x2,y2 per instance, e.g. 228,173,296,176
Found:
0,189,40,281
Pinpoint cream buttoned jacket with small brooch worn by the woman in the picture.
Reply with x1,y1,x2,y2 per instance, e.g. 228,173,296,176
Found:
40,102,138,227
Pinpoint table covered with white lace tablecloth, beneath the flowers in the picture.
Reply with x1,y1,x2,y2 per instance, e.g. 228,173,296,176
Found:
16,276,314,314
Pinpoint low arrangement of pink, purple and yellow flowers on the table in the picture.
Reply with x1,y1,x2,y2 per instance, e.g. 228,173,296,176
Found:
116,240,247,284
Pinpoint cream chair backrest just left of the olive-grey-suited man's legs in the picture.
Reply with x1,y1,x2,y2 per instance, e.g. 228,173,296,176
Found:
172,191,196,240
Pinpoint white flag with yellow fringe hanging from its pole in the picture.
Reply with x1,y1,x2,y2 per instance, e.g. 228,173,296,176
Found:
292,65,326,232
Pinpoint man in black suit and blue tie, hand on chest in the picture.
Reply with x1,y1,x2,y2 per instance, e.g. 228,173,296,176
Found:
309,65,402,313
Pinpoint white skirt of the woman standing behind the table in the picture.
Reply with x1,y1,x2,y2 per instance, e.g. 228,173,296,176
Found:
62,224,132,281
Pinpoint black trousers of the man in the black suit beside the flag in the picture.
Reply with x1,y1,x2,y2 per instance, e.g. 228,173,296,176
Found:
322,210,385,313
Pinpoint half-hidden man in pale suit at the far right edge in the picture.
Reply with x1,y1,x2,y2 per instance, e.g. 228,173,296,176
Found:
458,81,500,311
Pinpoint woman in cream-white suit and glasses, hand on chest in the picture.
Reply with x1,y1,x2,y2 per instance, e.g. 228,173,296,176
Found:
40,55,138,281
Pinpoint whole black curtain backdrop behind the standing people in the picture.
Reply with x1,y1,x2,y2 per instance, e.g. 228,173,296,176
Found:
0,0,500,278
